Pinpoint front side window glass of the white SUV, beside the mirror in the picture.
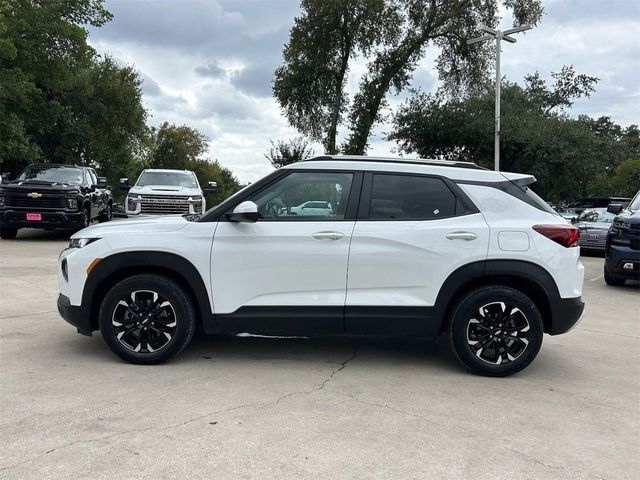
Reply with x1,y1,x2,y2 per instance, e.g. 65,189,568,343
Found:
250,172,353,220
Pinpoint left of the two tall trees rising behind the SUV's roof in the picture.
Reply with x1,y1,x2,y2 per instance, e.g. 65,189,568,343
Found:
273,0,397,154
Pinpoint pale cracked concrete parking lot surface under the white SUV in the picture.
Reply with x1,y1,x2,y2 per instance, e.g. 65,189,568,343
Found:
0,231,640,479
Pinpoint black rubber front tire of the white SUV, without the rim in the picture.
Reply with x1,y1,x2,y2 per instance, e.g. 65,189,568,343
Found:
99,275,195,365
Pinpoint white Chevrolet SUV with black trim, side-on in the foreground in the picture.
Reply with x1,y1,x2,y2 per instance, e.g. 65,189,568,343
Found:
58,156,584,376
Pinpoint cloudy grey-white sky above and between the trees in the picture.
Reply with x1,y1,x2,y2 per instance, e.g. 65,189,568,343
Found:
89,0,640,182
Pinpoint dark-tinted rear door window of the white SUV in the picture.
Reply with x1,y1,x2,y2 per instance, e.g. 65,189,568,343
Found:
369,174,456,220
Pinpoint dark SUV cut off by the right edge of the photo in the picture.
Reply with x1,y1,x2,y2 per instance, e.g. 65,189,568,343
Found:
604,191,640,285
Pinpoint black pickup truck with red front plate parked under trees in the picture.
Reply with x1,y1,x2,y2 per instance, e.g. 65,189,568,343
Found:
0,164,113,239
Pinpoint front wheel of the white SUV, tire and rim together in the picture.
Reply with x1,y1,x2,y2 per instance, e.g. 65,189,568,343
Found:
98,274,196,365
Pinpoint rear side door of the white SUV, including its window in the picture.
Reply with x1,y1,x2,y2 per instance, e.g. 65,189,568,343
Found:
345,173,489,335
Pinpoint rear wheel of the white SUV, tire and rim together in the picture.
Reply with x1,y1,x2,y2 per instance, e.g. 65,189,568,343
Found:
449,285,544,377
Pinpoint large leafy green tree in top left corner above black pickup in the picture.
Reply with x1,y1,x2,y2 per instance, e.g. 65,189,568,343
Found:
0,0,111,173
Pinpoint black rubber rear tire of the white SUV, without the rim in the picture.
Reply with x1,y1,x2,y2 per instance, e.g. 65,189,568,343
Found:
449,286,544,377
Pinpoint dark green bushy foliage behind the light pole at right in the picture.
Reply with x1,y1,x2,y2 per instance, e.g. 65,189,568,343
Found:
388,67,640,201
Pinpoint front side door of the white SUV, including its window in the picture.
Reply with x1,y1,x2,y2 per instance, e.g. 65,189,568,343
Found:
211,169,362,333
